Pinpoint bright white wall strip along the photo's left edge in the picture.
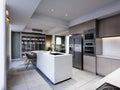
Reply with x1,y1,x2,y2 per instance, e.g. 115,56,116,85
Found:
0,0,6,90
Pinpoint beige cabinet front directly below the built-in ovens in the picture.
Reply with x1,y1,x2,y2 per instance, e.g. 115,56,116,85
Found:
83,55,96,73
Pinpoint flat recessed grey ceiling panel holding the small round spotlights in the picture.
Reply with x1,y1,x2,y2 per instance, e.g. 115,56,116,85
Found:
36,0,117,21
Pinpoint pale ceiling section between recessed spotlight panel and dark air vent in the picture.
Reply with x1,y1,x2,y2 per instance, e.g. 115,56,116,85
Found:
26,14,69,30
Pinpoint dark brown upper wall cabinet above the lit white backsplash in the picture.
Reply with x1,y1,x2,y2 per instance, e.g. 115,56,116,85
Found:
98,14,120,37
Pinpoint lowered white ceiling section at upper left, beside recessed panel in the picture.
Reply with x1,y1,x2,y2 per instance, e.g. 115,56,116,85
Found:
8,0,41,30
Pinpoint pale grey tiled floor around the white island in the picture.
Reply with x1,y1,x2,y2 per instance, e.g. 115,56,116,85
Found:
8,60,102,90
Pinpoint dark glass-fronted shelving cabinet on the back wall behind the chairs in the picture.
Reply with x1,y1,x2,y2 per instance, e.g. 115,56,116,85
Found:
21,32,45,54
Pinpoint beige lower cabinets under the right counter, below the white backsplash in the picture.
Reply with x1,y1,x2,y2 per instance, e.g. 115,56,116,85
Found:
97,57,120,76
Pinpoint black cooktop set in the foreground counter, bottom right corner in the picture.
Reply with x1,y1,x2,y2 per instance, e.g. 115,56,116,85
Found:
96,82,120,90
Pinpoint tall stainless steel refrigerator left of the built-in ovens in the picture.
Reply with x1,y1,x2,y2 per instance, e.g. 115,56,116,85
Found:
69,35,83,70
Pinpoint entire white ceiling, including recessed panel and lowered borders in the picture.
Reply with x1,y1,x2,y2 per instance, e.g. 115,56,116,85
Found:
7,0,120,33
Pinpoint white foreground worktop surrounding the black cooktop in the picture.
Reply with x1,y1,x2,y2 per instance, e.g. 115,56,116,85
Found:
87,68,120,90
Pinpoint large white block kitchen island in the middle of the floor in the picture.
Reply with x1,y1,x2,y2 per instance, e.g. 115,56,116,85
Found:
36,51,72,84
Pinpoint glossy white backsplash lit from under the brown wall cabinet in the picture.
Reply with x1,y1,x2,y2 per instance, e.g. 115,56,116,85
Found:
103,37,120,56
